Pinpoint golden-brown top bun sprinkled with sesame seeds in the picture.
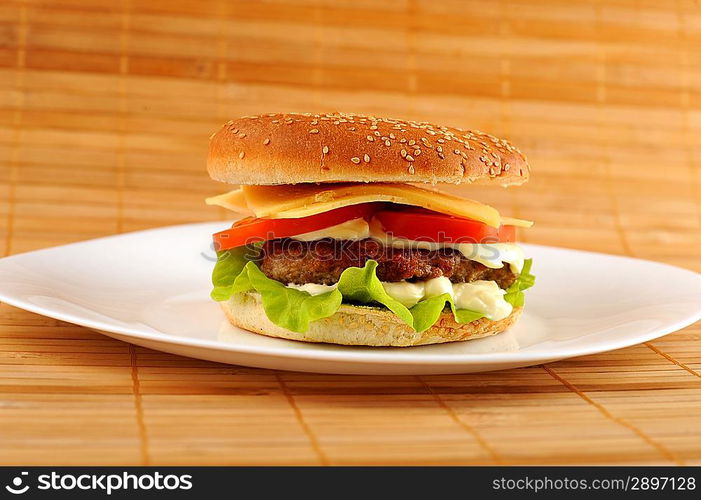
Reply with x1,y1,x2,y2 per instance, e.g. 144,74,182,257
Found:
207,113,530,186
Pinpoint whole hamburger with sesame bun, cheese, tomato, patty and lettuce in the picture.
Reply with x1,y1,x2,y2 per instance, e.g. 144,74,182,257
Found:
206,113,534,346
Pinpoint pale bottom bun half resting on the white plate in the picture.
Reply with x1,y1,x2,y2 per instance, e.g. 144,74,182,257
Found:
220,292,521,347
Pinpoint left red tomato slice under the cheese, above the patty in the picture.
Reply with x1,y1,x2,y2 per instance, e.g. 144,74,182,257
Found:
214,203,379,252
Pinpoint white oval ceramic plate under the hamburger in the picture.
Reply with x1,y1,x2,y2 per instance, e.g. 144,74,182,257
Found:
0,222,701,375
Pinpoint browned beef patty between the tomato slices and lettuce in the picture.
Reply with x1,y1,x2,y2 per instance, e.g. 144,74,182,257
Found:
260,238,518,288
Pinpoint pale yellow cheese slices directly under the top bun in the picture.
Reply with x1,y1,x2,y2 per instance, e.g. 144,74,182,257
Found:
206,182,533,227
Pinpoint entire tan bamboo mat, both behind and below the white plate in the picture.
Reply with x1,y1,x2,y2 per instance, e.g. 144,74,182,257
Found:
0,0,701,464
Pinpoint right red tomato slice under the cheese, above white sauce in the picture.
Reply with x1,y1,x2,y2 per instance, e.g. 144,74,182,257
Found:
374,208,516,243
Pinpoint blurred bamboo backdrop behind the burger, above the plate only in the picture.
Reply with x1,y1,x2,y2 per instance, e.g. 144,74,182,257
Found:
0,0,701,270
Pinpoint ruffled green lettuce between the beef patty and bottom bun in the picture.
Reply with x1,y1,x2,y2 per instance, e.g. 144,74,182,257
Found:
212,247,535,332
